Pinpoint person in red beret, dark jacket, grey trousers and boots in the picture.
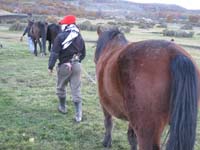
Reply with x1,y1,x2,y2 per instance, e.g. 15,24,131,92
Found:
48,15,86,122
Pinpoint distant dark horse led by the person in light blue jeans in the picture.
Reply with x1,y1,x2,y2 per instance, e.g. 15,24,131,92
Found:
30,21,48,56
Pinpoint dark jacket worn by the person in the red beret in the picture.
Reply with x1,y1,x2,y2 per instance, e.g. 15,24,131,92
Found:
48,31,86,70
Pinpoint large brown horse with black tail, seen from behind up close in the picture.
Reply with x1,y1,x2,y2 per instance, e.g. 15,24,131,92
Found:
95,29,200,150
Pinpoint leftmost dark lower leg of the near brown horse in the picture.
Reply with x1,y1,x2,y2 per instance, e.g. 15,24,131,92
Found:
103,108,113,147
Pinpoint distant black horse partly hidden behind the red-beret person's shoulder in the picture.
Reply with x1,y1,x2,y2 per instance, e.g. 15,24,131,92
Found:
47,23,61,52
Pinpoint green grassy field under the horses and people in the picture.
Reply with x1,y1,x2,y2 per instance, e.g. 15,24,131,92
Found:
0,24,200,150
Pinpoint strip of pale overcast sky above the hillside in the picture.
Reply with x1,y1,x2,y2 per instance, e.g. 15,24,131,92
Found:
128,0,200,9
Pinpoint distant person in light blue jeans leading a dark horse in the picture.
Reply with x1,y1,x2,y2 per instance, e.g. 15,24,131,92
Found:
20,14,35,53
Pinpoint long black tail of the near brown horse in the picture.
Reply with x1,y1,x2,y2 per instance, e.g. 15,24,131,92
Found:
167,55,198,150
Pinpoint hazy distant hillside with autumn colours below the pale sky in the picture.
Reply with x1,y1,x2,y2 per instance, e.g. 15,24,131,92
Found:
0,0,200,19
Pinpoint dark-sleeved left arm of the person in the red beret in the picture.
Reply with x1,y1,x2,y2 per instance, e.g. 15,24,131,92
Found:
48,36,62,71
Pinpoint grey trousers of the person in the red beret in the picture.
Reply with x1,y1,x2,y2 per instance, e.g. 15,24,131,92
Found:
56,62,81,102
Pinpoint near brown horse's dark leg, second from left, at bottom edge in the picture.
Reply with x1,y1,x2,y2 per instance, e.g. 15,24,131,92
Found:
127,124,137,150
